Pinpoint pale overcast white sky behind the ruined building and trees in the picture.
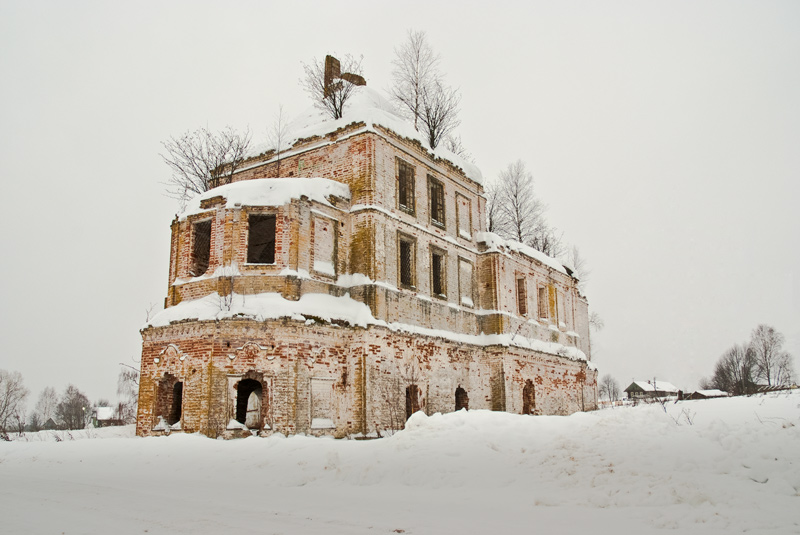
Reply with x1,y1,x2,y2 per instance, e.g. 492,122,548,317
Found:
0,0,800,408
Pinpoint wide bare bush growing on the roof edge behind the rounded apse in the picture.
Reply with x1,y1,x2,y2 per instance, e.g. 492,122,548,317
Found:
161,126,250,205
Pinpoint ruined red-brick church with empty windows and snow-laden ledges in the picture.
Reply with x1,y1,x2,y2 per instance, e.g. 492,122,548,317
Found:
136,62,597,438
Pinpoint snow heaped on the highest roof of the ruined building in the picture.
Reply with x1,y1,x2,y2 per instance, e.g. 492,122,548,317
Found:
247,86,483,184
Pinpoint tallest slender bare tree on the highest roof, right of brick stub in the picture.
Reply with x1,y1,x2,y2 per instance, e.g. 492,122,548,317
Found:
389,30,440,130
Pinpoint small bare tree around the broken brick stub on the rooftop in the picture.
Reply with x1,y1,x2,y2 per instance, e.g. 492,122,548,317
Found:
300,54,364,119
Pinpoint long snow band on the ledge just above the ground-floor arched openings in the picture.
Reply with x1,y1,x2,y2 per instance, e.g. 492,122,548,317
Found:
145,293,593,369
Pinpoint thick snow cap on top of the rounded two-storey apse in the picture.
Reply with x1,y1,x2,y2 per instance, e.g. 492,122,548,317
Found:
180,177,350,219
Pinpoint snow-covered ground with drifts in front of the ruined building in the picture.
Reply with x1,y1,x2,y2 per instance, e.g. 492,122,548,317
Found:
0,392,800,535
